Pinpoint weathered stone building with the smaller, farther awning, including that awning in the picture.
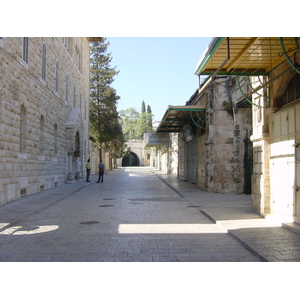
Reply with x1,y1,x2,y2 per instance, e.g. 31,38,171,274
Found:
157,77,252,193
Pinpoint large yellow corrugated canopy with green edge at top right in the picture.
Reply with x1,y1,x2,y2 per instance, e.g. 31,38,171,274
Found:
195,37,300,76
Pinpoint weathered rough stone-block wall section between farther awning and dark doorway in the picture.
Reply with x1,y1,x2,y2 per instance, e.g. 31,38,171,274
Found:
206,78,252,193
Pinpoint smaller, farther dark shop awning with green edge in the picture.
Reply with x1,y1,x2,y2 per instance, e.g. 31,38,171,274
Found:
156,105,205,132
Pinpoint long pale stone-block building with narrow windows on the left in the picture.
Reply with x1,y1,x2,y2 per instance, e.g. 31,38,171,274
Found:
0,37,101,205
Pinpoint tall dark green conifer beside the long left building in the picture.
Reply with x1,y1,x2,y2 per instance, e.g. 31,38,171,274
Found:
90,39,122,163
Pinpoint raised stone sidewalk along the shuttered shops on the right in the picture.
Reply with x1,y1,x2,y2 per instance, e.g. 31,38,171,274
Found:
153,170,300,262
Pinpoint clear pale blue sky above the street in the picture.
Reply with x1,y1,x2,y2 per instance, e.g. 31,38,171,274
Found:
107,37,212,121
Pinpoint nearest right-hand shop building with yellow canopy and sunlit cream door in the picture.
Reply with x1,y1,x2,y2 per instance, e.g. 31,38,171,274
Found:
195,37,300,223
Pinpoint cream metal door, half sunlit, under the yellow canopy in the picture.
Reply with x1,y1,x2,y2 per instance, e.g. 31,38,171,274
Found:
270,107,300,222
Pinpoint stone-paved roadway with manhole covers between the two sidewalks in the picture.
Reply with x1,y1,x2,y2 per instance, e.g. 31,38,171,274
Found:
0,167,261,262
